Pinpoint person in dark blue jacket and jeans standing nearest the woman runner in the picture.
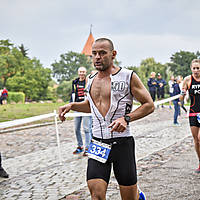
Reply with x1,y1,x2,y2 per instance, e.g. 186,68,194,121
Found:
172,77,181,126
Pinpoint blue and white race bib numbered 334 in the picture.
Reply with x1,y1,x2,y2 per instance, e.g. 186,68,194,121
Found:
88,140,111,163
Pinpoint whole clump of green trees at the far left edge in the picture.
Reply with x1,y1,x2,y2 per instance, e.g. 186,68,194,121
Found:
0,40,51,100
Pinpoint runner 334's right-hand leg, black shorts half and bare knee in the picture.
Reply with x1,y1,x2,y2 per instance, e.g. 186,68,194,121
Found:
112,137,139,200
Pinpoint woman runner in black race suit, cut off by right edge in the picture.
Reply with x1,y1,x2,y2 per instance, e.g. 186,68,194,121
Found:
180,59,200,173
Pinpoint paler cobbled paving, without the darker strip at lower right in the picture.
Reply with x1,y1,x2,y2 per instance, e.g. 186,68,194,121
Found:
0,108,195,200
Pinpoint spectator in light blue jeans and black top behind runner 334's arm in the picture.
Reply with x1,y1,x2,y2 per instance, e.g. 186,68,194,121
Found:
71,67,91,156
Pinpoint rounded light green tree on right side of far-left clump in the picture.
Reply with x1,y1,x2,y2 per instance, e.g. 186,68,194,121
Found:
7,58,51,101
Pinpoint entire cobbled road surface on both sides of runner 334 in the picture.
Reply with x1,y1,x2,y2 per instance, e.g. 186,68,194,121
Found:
0,108,200,200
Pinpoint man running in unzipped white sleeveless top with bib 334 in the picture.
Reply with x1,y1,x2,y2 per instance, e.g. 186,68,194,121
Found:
59,38,154,200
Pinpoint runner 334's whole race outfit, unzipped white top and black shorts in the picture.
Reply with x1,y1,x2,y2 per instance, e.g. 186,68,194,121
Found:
87,68,137,186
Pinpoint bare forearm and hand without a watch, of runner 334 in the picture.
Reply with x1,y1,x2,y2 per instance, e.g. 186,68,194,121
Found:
58,100,91,121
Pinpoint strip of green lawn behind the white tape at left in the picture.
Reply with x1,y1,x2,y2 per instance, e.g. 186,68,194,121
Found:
0,103,64,122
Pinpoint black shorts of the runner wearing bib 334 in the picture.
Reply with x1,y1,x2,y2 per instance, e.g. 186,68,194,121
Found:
87,136,137,186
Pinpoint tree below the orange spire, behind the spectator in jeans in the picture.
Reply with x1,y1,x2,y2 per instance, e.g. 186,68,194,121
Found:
52,51,92,83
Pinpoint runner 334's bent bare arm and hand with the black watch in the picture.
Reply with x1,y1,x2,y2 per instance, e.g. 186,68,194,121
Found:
109,73,155,132
